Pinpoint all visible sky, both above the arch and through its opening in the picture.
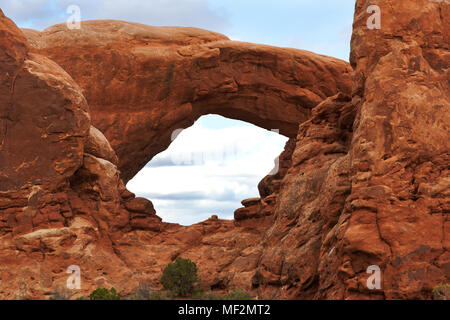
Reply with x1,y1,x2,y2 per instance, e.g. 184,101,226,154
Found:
0,0,355,225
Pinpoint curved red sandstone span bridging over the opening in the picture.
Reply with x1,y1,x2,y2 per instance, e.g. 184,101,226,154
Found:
24,21,351,182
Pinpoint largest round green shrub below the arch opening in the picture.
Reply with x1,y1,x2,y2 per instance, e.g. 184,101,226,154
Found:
161,258,198,297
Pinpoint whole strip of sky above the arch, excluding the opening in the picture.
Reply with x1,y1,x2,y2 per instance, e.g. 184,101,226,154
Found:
0,0,355,61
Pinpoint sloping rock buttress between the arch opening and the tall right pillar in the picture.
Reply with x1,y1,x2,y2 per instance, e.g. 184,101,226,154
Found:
253,94,355,299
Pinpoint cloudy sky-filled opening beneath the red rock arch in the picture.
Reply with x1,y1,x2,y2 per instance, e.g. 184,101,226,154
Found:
127,114,288,225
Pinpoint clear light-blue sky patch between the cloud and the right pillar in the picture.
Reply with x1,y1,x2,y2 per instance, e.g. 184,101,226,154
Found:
211,0,354,61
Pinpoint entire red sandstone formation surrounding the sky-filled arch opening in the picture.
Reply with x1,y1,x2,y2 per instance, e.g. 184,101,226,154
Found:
0,0,450,299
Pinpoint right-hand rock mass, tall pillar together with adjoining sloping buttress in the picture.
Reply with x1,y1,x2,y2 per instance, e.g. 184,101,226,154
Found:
250,0,450,299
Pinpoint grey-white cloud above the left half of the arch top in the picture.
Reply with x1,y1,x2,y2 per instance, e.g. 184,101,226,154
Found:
1,0,229,32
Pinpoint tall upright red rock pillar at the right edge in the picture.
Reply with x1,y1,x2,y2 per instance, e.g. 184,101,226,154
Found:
341,0,450,299
